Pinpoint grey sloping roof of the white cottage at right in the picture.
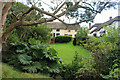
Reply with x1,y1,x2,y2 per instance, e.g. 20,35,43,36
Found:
91,16,120,33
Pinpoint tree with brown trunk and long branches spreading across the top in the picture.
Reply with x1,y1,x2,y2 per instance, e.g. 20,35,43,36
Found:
2,0,115,43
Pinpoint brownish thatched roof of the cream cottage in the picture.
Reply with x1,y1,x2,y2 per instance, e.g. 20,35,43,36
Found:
46,22,80,30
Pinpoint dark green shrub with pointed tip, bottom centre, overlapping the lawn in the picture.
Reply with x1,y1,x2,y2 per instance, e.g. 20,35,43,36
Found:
59,53,83,80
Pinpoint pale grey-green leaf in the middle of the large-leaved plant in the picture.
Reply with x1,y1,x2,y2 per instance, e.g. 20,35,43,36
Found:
18,54,32,64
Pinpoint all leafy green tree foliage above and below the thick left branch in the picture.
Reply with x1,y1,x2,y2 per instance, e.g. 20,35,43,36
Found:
4,2,51,43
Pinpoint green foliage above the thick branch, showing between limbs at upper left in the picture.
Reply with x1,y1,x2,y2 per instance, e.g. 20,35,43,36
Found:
4,2,43,31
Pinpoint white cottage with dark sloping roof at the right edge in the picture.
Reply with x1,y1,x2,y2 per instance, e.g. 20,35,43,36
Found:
89,16,120,37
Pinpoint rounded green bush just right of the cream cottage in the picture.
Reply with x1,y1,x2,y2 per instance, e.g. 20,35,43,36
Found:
76,27,88,44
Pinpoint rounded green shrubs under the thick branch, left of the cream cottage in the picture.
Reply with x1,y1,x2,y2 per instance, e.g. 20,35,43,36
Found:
7,24,51,43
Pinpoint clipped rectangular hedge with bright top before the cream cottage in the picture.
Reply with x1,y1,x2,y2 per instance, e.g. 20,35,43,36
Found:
55,35,72,43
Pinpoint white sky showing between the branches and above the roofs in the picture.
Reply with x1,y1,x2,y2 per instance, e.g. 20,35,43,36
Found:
19,0,118,26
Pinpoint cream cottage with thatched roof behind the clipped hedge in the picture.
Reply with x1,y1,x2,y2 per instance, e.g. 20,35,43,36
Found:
46,22,80,38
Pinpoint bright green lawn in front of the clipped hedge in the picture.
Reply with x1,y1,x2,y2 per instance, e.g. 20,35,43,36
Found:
50,42,91,64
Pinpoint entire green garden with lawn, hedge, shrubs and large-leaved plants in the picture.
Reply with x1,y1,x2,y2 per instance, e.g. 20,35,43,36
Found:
0,2,120,80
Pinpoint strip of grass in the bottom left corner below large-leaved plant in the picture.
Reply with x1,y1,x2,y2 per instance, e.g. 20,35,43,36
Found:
0,63,50,80
